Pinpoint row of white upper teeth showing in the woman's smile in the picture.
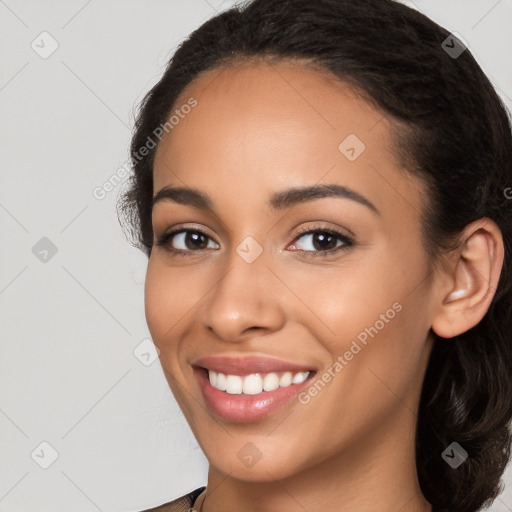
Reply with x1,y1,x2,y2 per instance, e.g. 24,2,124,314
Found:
208,370,310,395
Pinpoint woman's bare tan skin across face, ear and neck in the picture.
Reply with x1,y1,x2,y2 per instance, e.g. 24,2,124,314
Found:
145,62,503,512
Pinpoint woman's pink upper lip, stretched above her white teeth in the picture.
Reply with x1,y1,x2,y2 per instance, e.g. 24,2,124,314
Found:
192,356,311,375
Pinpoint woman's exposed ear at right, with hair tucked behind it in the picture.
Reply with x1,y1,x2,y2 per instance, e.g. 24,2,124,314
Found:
432,218,505,338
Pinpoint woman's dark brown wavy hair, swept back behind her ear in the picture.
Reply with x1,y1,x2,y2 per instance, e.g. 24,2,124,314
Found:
118,0,512,512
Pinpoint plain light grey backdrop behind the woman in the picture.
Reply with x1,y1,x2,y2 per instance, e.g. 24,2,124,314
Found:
0,0,512,512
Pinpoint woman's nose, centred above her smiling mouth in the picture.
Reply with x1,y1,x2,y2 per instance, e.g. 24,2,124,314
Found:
199,245,289,342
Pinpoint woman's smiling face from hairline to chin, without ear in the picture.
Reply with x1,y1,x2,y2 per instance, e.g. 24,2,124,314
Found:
145,63,434,481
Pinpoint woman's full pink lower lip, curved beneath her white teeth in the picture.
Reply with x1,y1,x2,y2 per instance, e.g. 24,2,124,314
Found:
194,368,314,423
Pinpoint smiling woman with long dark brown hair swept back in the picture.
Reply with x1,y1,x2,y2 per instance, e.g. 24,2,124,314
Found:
120,0,512,512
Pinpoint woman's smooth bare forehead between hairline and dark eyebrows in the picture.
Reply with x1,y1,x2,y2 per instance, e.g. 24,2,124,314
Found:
154,61,420,220
